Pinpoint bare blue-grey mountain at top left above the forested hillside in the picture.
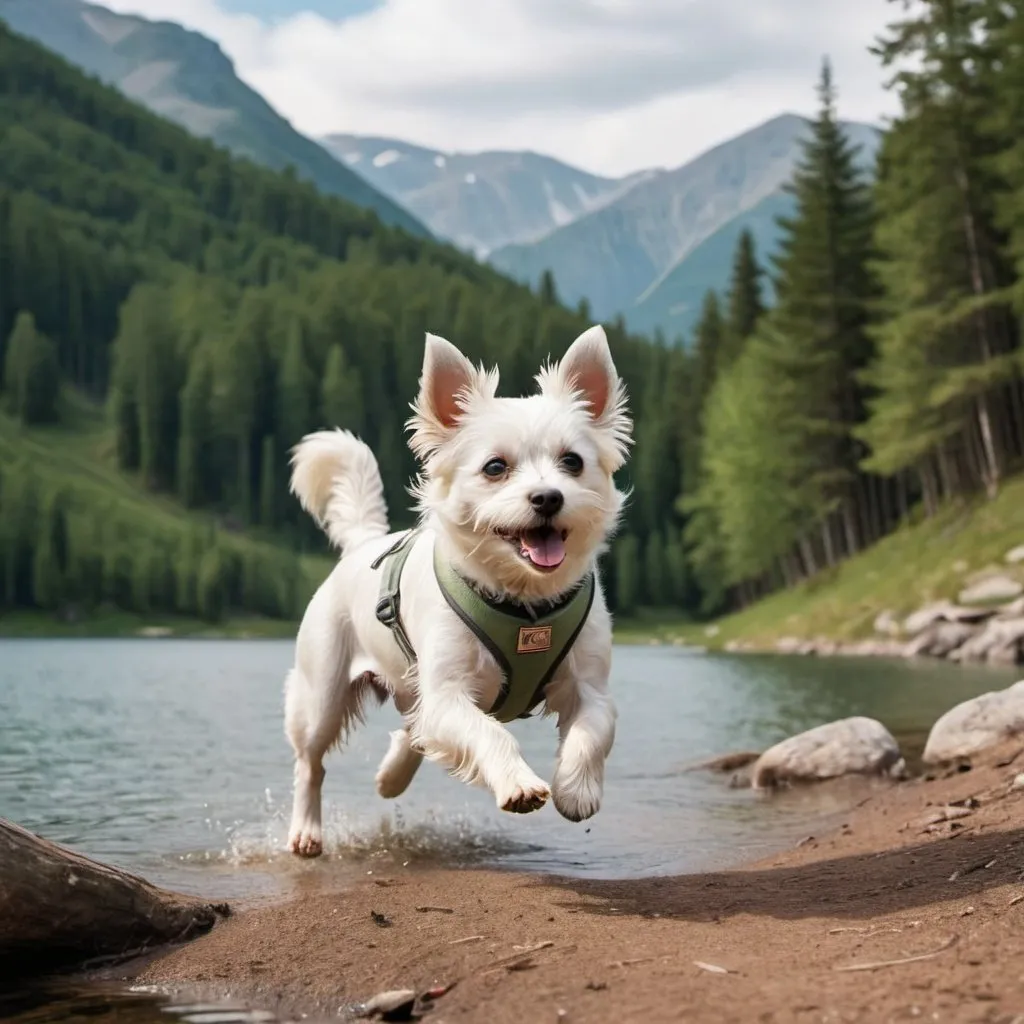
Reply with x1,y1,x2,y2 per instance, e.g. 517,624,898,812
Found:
0,0,429,237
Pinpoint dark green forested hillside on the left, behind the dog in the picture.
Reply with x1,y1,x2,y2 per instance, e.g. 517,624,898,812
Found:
0,27,696,615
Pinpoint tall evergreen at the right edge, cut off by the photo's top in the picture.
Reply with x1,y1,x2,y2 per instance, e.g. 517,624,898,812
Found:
860,0,1024,499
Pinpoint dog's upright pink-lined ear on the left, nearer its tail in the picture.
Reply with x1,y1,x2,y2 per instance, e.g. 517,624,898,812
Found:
408,334,498,459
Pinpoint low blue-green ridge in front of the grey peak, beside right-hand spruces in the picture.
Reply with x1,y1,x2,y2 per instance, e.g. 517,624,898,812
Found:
625,191,795,339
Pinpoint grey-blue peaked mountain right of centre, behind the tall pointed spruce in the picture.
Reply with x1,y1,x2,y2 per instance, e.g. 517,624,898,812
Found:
489,114,880,331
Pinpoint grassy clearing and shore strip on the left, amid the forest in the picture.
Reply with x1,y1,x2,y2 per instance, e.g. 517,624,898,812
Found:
0,390,333,637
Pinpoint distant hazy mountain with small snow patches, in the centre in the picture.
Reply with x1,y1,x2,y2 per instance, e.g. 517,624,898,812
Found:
322,134,657,256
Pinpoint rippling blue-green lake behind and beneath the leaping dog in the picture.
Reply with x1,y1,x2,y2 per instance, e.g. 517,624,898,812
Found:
0,640,1018,900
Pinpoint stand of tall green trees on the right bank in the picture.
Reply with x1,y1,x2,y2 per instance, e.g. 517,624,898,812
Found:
681,0,1024,600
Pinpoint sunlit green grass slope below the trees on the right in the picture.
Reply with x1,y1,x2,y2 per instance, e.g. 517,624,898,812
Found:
623,476,1024,647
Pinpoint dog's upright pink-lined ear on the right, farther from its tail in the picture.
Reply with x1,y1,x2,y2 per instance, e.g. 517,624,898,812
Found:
538,324,633,468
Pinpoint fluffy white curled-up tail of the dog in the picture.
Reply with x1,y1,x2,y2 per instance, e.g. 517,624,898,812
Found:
292,430,388,551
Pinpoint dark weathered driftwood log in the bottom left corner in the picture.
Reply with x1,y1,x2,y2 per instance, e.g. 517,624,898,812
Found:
0,818,228,977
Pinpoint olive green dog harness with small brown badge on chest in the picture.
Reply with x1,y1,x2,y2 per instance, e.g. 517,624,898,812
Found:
373,529,595,722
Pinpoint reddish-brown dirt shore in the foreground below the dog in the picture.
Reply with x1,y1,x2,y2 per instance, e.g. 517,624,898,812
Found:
123,743,1024,1024
